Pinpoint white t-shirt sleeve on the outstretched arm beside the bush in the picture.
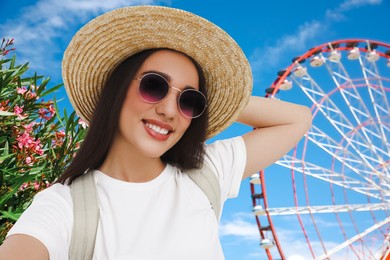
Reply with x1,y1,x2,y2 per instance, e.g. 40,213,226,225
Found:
7,184,73,259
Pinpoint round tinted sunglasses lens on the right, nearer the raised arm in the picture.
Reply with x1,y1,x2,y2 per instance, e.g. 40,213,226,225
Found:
179,89,206,118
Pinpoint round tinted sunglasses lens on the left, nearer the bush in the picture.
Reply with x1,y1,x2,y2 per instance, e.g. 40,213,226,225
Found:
139,73,169,103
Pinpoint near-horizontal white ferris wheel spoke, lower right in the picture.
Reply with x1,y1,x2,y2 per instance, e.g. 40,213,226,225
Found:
265,203,390,216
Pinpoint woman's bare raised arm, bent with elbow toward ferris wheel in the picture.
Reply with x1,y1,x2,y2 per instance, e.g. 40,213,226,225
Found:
237,96,312,178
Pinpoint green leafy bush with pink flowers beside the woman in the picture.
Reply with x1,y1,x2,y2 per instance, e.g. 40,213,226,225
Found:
0,39,86,244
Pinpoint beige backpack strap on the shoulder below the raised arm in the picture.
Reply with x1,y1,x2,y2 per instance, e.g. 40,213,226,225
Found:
187,164,221,221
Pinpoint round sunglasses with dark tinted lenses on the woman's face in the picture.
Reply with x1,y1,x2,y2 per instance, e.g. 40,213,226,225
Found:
136,72,207,118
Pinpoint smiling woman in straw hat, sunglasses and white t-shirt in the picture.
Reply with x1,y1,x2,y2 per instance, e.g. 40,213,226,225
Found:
0,6,311,259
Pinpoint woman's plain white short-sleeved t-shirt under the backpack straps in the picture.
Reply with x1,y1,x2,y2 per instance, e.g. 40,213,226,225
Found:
8,137,246,260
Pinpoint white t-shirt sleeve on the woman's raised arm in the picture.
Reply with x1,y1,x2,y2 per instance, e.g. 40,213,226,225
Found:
205,136,246,201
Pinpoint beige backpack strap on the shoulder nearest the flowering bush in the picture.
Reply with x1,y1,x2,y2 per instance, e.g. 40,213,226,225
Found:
69,172,99,260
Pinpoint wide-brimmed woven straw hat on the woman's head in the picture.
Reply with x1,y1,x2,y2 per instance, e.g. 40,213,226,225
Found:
62,6,252,138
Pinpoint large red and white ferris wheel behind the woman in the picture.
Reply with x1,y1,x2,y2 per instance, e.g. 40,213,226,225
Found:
250,39,390,259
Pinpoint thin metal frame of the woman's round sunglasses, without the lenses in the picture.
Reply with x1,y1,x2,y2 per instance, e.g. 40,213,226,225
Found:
135,72,207,119
